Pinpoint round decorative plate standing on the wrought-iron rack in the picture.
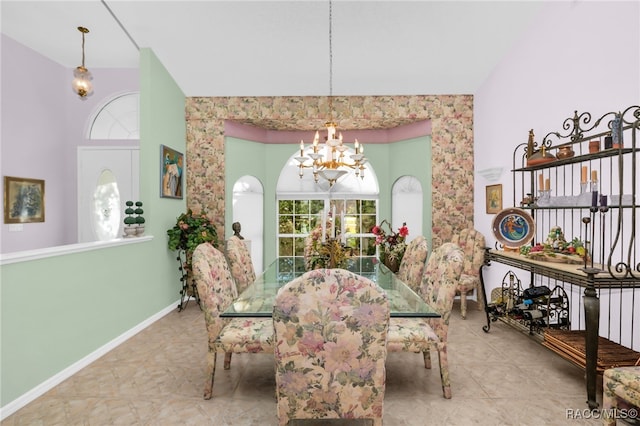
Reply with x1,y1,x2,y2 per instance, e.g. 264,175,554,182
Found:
493,208,536,249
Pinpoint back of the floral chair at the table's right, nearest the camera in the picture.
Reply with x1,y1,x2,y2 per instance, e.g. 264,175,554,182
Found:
419,243,464,341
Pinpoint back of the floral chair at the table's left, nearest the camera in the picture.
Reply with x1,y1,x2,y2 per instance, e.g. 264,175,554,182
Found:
191,243,236,343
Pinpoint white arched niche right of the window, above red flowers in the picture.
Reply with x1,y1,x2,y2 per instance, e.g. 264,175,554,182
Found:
391,176,424,241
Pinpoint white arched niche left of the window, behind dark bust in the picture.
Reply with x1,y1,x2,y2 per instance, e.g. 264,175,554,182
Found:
232,175,264,272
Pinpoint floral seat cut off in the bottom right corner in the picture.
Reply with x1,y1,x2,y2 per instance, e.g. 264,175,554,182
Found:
600,360,640,426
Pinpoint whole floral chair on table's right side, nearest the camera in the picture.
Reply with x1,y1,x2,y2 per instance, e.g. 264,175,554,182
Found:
387,243,464,398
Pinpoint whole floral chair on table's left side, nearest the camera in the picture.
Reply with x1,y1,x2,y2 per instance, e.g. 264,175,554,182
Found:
192,243,273,399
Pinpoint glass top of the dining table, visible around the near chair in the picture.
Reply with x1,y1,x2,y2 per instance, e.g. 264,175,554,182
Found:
220,259,440,318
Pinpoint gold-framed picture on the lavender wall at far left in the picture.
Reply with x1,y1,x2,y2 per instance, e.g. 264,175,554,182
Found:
4,176,44,223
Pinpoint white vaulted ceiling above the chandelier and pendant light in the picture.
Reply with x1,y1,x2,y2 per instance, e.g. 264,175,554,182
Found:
0,0,544,96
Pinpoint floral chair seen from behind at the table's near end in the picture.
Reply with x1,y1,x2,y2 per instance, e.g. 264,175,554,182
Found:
273,269,389,426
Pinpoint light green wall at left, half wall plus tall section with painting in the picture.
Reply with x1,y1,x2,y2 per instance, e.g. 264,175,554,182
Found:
0,49,186,407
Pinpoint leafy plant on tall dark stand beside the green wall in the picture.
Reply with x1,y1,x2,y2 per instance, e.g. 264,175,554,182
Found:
167,209,219,310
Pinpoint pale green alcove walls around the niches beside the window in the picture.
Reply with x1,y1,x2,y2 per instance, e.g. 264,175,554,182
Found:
225,136,432,265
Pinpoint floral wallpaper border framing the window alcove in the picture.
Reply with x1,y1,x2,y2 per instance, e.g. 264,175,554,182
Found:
186,95,473,247
